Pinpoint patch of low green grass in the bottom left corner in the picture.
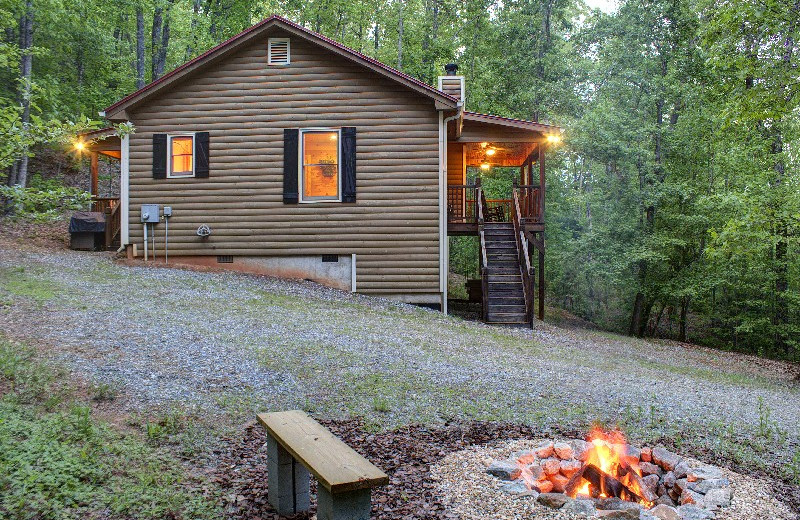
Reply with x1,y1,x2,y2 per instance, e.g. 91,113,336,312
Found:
0,337,220,520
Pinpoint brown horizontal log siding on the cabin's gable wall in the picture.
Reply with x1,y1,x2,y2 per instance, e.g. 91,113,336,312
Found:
128,28,441,297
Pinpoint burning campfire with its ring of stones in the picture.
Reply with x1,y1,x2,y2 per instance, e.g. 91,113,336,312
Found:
487,428,732,518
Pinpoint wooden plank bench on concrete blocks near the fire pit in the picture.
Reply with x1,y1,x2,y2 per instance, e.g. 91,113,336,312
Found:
258,410,389,520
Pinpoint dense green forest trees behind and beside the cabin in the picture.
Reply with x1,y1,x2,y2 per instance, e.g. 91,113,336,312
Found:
0,0,800,359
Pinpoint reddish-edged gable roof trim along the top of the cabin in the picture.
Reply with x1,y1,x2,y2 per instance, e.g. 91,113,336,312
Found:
104,15,458,120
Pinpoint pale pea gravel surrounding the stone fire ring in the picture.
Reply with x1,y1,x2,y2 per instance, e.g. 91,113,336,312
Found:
431,439,796,520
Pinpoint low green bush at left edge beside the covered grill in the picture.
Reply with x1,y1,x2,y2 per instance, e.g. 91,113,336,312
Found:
0,176,91,221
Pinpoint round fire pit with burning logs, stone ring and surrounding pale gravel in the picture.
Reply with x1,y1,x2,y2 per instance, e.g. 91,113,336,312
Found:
432,430,793,520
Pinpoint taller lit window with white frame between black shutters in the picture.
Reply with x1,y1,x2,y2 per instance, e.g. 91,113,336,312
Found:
300,130,341,202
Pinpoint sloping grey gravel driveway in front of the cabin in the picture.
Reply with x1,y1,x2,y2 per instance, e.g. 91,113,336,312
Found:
0,243,800,471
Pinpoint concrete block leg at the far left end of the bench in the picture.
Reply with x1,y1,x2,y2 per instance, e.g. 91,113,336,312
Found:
267,434,311,516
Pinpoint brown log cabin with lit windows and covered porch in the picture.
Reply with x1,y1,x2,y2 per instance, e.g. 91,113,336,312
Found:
84,16,560,324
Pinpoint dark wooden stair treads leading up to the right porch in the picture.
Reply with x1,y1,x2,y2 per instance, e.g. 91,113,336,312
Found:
484,222,530,325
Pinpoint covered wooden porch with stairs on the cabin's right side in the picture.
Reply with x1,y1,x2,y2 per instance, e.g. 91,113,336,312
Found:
447,112,561,323
